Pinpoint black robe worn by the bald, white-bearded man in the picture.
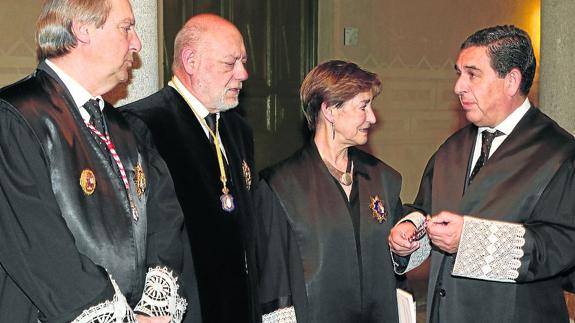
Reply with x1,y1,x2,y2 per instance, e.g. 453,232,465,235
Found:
120,86,259,323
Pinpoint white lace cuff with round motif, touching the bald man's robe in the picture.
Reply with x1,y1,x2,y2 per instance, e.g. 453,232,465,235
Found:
134,267,188,323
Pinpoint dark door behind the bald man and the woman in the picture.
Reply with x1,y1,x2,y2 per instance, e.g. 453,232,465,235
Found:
164,0,317,169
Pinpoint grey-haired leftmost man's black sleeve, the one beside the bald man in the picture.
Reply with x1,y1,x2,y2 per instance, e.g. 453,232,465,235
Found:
122,110,201,322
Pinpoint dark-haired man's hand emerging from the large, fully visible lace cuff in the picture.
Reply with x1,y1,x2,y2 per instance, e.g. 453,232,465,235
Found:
427,211,463,253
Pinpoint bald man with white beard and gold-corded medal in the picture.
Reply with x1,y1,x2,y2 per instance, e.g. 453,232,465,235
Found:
121,14,259,323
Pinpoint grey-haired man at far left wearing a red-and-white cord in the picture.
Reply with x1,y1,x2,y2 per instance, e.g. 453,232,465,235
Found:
0,0,199,323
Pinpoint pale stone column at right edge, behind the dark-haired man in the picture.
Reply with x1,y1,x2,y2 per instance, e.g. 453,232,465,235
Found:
539,0,575,133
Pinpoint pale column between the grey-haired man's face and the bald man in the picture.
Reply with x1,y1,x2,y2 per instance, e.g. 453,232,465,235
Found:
105,0,161,107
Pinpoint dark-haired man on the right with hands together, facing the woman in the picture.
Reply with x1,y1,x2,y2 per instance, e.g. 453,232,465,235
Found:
389,26,575,323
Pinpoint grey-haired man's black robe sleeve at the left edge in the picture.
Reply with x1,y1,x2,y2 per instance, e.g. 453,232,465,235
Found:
0,101,114,322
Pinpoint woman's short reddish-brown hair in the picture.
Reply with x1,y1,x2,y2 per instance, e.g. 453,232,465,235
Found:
300,60,381,132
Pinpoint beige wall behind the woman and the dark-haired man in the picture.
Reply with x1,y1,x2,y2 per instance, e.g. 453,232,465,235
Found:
318,0,540,202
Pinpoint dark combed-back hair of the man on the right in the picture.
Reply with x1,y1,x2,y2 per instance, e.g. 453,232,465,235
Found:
461,25,537,95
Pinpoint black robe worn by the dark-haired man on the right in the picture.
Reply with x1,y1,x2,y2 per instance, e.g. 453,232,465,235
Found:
415,107,575,323
